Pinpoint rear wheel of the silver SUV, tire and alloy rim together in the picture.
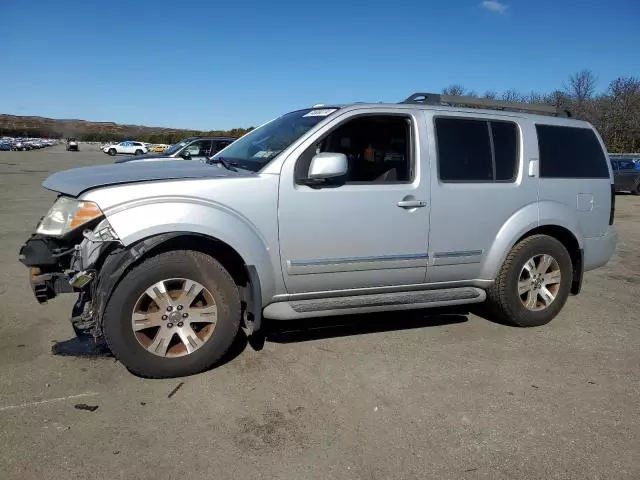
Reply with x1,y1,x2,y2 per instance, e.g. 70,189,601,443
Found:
487,235,573,327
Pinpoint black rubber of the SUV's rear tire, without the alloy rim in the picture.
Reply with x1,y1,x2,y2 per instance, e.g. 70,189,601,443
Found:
487,235,573,327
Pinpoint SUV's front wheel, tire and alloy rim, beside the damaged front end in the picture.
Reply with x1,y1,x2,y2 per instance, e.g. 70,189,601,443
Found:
103,250,241,378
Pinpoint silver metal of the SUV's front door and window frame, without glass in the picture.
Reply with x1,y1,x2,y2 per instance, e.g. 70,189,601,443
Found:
279,108,430,293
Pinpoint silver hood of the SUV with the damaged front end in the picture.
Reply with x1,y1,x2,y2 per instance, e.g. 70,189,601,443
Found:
42,160,255,197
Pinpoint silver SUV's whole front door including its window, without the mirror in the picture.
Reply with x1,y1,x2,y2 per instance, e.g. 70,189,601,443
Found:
278,109,429,293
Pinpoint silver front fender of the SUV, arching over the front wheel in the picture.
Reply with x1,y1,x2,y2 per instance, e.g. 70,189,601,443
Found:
81,173,284,304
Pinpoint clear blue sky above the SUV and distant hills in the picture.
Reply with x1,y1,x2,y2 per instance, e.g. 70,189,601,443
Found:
0,0,640,130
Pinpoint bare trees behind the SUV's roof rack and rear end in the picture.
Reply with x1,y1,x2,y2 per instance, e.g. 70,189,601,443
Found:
442,70,640,153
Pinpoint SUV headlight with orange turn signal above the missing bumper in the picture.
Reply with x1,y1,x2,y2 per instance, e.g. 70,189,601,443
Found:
36,197,104,236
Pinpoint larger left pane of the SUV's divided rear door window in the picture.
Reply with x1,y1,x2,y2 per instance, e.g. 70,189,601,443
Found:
435,118,493,181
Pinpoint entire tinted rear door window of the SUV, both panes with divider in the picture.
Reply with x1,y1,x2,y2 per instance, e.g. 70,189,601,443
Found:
435,117,518,182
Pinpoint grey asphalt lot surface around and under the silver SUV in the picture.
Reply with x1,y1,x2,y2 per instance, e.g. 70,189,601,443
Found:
0,144,640,480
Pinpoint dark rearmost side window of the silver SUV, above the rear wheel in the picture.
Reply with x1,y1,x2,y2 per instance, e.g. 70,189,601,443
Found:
536,125,609,178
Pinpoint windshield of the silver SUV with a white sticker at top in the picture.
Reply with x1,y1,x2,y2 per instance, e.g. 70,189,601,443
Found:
212,108,337,172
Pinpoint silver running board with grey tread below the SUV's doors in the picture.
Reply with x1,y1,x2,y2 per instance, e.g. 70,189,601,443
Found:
263,287,487,320
